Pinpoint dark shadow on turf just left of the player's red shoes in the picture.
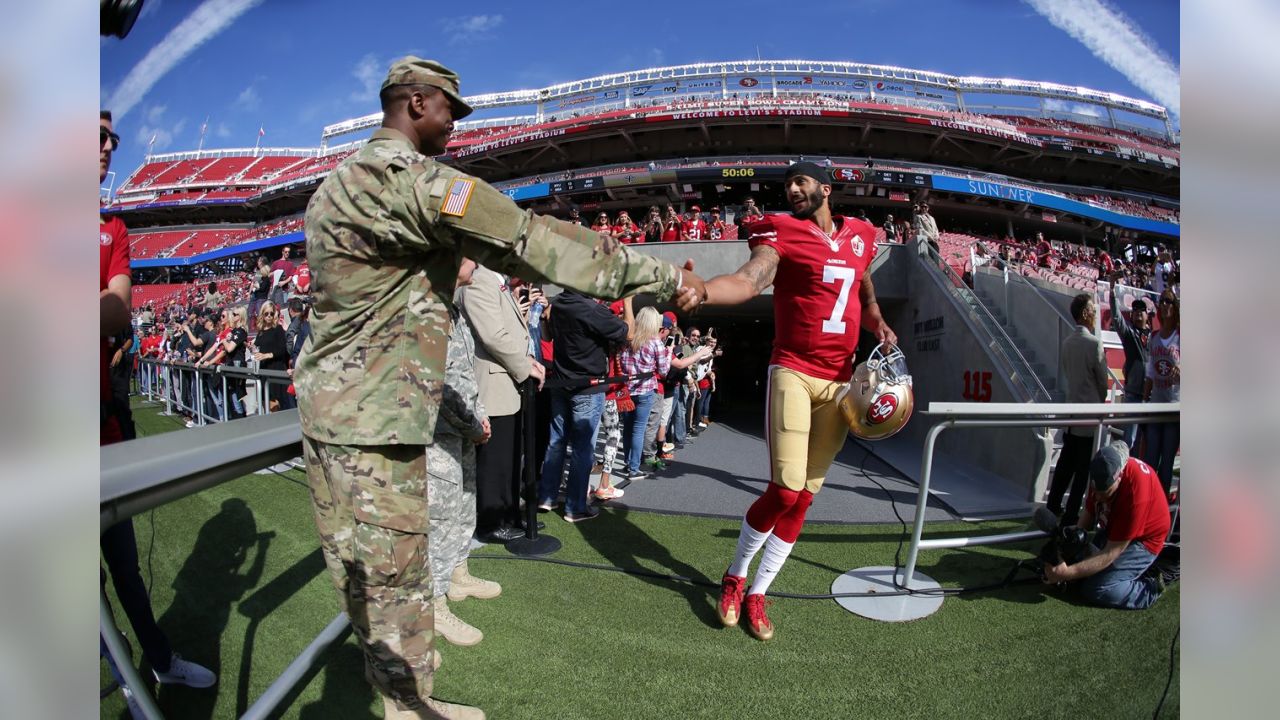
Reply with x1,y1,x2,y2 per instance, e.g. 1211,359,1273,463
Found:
579,509,721,628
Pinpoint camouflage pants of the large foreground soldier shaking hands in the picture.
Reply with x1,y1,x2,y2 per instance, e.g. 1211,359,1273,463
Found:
302,436,435,710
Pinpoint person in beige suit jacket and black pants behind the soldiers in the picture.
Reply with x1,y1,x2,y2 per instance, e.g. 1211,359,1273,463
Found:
454,266,547,543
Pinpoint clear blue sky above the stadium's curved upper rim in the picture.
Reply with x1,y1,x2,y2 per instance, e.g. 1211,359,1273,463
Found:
100,0,1180,177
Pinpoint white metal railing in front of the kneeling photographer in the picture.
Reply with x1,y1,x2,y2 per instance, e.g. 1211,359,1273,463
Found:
895,402,1181,589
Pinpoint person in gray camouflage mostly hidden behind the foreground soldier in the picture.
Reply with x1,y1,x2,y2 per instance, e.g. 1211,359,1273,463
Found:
426,259,502,646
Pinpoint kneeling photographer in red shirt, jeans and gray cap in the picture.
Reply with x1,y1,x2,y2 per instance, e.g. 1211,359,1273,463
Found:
1044,442,1170,610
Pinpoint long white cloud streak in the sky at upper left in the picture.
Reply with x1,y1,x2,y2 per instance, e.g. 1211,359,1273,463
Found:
106,0,262,119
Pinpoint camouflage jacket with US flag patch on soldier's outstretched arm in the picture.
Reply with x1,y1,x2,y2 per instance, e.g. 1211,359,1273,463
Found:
294,128,680,445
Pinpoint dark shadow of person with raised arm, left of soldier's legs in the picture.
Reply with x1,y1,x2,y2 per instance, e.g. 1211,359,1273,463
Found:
157,498,275,717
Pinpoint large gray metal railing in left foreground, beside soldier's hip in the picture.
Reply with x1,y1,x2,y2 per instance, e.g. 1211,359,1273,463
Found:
99,410,330,720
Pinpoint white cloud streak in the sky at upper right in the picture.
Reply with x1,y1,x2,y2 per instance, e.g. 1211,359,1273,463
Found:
1024,0,1181,115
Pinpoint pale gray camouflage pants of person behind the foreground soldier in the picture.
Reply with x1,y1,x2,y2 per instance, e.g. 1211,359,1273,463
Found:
426,434,476,596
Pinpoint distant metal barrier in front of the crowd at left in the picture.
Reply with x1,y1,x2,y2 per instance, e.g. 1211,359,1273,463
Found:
138,357,293,425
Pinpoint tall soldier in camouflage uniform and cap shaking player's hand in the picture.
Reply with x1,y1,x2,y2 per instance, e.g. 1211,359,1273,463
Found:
294,58,707,717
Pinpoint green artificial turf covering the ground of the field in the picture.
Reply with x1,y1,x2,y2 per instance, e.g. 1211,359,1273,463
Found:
101,397,1179,720
